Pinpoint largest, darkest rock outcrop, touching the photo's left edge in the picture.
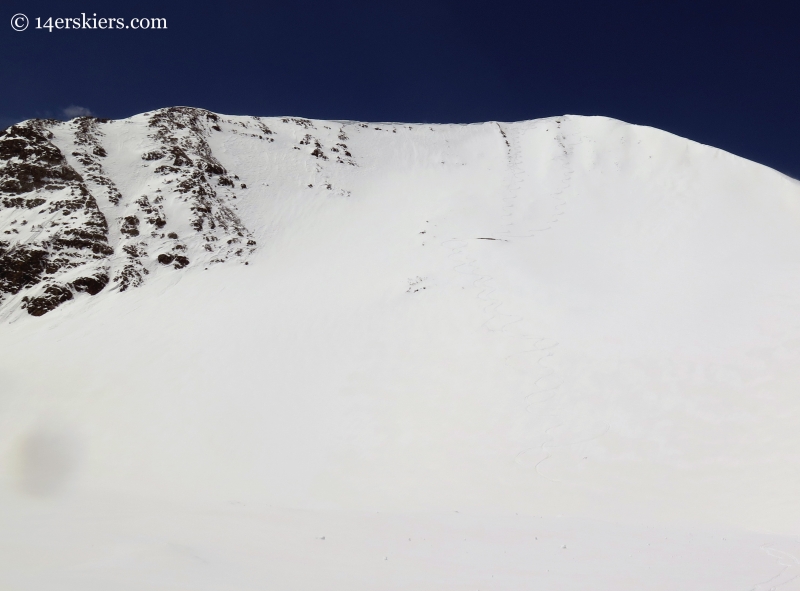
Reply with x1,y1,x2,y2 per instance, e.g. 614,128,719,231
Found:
0,120,113,316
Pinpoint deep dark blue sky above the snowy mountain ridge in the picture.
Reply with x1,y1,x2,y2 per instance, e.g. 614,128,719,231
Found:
0,0,800,178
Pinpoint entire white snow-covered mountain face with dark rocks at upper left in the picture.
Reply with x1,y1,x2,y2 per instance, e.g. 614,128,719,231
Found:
0,109,800,590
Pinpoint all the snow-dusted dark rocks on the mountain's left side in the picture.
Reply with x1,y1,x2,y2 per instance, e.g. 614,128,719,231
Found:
0,107,260,316
